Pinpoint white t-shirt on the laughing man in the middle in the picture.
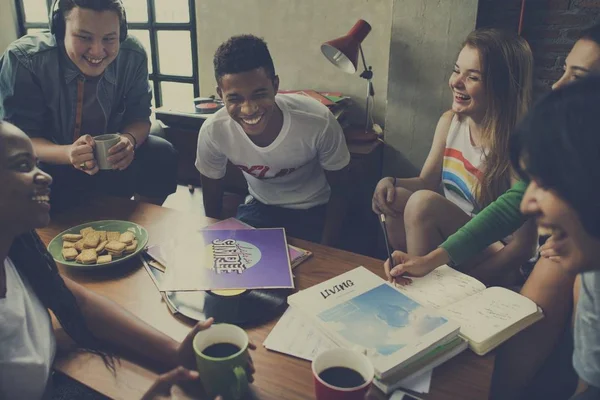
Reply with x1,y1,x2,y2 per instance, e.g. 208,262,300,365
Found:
196,95,350,209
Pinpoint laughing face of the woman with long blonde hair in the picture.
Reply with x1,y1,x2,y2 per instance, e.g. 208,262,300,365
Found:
448,46,487,119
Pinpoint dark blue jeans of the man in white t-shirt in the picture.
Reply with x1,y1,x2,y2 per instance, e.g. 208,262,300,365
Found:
236,198,327,243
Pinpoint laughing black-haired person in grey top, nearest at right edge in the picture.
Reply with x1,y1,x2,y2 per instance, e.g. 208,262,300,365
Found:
510,77,600,399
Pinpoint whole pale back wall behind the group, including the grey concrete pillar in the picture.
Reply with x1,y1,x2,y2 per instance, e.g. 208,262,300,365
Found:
0,0,478,176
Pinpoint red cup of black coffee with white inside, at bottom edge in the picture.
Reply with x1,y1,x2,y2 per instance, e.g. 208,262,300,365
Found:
312,348,375,400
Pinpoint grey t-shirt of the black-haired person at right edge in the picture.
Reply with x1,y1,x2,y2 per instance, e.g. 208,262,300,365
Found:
573,271,600,387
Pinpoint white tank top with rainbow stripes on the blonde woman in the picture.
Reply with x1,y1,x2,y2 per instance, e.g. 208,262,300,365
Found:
442,115,484,216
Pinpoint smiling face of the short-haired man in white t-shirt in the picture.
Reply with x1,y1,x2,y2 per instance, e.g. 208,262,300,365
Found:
217,68,281,138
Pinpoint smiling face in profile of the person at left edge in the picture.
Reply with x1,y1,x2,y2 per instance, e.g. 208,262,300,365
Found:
0,122,52,235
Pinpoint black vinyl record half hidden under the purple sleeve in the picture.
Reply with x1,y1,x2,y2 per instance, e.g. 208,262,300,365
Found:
166,289,293,326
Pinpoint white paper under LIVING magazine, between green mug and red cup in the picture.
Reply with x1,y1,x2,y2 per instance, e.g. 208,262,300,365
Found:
263,307,338,361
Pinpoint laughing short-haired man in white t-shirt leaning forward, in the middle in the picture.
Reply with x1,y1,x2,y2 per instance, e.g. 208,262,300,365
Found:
196,35,350,244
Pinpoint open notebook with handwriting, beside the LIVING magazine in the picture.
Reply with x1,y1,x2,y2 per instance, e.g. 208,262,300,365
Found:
397,265,544,355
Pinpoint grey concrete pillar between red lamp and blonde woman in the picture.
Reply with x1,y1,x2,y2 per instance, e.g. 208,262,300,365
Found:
384,0,478,176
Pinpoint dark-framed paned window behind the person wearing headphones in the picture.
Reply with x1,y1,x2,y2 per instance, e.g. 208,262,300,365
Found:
15,0,200,107
